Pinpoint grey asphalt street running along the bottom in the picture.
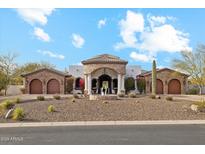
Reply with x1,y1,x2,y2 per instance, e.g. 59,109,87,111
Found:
0,125,205,144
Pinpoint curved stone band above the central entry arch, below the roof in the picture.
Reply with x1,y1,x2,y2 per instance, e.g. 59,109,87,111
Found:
83,64,126,74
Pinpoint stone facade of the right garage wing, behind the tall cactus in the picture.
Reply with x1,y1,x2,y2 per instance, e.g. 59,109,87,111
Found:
145,70,187,94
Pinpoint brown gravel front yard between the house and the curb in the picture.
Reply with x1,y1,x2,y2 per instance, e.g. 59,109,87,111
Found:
0,96,205,122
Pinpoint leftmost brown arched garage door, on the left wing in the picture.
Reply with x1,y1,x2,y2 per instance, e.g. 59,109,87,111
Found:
30,79,43,94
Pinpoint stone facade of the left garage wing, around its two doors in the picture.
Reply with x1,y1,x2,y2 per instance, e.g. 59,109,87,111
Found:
25,70,65,94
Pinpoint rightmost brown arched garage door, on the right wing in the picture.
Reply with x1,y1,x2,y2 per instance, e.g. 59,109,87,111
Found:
168,79,181,94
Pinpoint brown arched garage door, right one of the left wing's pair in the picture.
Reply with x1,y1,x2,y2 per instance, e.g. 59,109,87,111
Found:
47,79,60,94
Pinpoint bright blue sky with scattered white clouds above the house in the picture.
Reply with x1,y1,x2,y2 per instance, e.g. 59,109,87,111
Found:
0,9,205,70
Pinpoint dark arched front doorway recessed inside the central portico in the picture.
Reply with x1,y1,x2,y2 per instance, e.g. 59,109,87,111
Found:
98,74,112,94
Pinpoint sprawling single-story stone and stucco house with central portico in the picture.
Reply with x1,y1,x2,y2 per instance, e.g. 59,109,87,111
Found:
22,54,188,95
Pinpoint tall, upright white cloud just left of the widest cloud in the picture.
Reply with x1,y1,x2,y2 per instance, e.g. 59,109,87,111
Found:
115,10,144,49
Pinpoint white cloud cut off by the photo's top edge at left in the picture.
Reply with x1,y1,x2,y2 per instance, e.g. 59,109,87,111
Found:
17,8,54,25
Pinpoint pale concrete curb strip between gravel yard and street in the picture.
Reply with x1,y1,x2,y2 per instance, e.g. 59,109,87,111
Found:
0,120,205,128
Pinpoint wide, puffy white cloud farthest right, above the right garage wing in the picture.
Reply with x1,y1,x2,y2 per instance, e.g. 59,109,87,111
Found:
140,24,190,52
